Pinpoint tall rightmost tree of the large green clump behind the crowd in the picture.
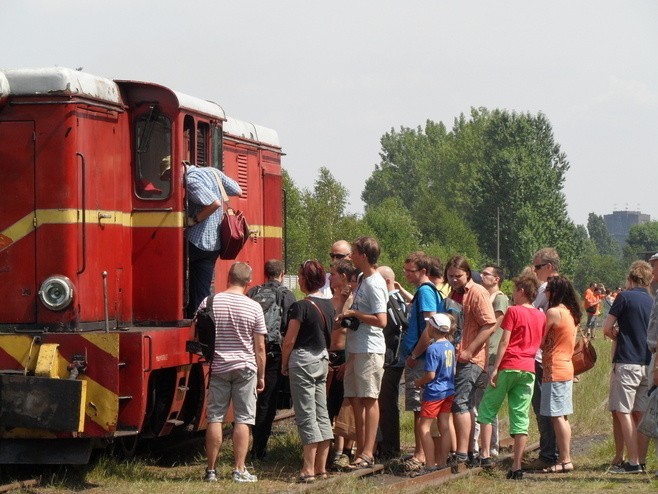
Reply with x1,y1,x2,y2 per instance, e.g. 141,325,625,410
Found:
468,110,575,274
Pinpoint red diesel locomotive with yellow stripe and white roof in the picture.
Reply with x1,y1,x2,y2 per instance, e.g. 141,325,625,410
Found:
0,68,282,463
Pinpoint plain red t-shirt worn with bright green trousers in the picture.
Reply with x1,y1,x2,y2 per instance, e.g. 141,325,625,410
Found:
498,305,546,374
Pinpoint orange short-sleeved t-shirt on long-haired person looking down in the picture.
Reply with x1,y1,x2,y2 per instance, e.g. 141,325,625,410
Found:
461,280,496,369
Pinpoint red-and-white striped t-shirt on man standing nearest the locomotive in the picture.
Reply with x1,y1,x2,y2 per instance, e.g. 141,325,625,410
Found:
199,292,267,374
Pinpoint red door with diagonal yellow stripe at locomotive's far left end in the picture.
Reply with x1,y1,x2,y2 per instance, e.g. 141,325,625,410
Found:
0,121,37,323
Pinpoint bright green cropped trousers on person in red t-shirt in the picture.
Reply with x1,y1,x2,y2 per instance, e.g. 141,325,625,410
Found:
478,370,535,436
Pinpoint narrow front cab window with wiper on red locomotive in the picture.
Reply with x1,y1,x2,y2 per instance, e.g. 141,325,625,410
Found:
135,106,171,199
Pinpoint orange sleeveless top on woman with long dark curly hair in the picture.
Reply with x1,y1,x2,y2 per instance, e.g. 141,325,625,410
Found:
541,305,576,383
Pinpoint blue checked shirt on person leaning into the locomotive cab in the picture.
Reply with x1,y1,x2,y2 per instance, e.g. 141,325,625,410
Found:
185,166,242,251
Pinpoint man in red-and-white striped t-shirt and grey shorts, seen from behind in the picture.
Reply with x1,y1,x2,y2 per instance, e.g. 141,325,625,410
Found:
201,262,267,482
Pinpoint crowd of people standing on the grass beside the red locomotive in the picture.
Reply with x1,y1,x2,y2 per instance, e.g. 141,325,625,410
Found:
191,237,658,483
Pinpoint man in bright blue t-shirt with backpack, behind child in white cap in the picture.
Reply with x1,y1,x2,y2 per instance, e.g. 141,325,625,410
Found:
400,252,444,470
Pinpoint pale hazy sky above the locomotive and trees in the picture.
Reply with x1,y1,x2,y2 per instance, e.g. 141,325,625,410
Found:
5,0,658,224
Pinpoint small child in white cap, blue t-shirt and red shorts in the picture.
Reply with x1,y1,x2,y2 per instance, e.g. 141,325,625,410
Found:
414,313,456,475
